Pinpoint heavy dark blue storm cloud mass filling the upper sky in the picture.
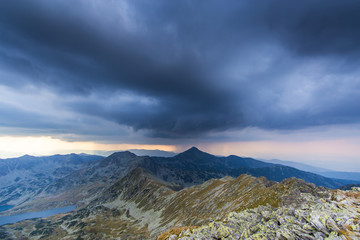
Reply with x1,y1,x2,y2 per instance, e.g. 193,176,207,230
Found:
0,0,360,137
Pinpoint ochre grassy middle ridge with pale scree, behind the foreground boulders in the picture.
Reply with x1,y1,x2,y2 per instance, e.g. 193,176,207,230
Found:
0,168,329,239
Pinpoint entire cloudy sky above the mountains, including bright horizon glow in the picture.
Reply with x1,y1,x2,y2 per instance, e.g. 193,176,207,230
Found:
0,0,360,171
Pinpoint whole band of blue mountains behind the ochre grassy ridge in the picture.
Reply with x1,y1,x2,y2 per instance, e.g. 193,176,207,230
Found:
0,147,357,213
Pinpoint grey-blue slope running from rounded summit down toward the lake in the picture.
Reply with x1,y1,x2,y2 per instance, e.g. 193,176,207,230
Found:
3,151,144,214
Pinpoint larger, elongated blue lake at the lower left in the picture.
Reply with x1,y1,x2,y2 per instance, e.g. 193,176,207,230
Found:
0,205,76,226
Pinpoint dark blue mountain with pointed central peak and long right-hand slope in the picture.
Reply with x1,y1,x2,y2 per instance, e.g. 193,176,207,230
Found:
140,147,343,188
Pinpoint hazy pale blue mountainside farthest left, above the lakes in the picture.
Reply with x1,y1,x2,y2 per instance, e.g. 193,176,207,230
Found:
0,154,103,208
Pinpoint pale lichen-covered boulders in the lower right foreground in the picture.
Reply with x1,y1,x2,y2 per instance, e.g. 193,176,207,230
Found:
159,188,360,240
